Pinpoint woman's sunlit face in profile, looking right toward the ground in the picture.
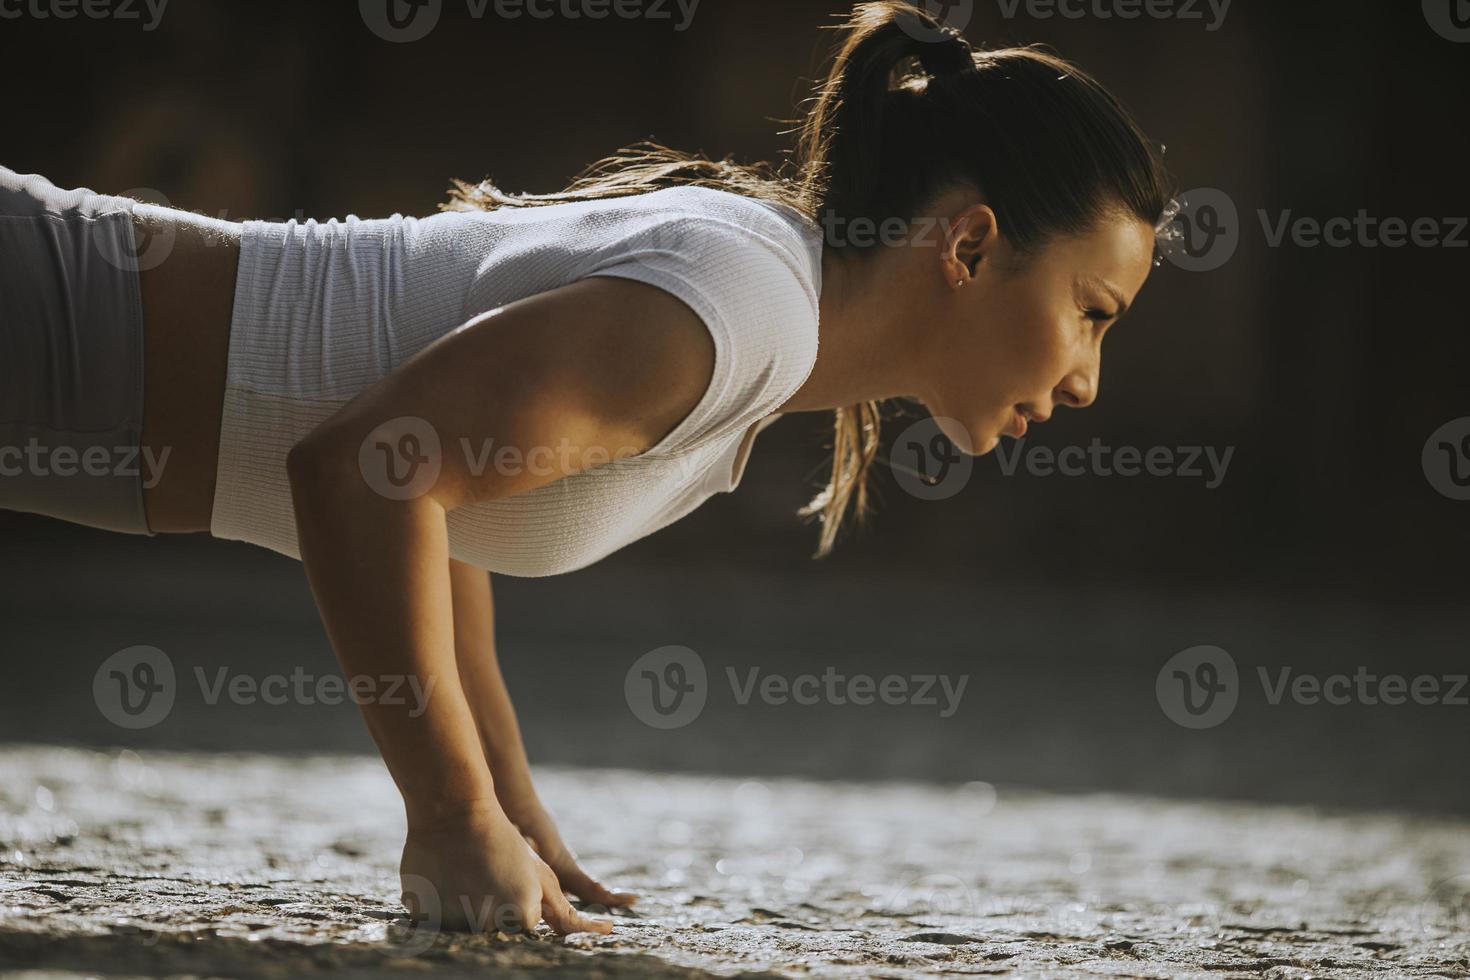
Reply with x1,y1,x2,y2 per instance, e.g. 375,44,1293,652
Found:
919,206,1154,455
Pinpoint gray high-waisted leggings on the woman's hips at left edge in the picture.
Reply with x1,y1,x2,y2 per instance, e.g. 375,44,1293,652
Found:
0,166,157,535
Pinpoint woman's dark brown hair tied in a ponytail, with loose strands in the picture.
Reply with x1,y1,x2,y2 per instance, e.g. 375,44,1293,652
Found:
445,0,1172,557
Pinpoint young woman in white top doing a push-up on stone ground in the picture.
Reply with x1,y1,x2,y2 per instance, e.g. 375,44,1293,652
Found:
0,1,1170,932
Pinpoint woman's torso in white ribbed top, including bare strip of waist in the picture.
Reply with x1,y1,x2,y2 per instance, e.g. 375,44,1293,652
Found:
143,188,820,574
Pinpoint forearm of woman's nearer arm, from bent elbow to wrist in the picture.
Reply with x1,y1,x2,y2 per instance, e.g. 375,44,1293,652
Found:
288,445,498,827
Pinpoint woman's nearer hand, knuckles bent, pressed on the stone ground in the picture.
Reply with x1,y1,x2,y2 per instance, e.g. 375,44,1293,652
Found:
398,807,613,934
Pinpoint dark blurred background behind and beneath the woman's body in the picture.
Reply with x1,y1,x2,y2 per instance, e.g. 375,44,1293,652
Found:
0,0,1470,813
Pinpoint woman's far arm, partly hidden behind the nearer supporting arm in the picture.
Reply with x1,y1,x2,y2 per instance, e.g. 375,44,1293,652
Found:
450,561,638,907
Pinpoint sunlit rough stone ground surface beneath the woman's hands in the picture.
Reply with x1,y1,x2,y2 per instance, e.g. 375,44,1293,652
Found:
0,748,1470,977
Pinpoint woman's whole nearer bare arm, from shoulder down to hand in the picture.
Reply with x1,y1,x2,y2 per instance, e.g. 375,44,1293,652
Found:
287,278,714,932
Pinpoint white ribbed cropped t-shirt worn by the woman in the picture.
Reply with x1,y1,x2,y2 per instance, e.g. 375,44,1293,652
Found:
210,187,822,576
